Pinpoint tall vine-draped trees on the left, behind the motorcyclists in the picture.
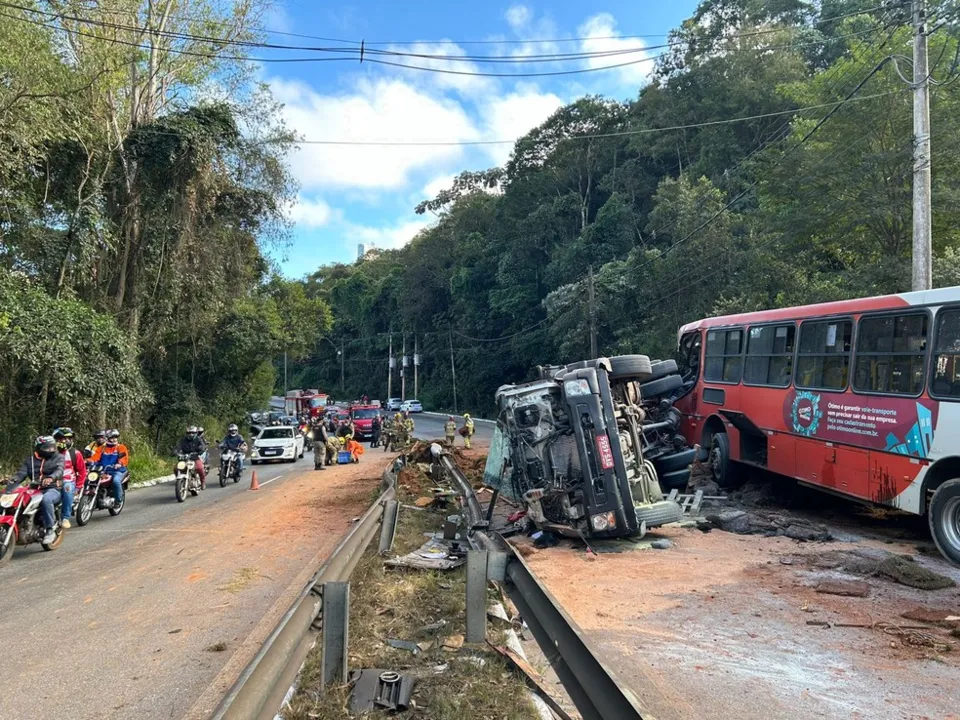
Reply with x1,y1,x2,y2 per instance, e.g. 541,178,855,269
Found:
0,0,331,460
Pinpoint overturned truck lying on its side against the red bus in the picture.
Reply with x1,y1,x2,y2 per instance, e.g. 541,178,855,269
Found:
485,355,696,537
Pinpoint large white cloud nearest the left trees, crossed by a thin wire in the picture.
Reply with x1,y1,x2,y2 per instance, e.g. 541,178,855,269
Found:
270,79,480,190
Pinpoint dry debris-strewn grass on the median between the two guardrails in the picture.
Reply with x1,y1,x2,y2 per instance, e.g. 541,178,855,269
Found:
283,476,538,720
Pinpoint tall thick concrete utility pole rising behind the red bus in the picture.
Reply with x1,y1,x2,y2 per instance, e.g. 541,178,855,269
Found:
912,0,933,290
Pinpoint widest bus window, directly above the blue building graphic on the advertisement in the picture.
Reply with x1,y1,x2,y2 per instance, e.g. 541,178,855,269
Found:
853,313,927,395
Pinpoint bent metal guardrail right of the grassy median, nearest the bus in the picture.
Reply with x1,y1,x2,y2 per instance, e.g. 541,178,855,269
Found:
431,444,643,720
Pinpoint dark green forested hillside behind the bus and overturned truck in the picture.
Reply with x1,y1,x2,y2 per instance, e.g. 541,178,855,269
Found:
296,0,960,412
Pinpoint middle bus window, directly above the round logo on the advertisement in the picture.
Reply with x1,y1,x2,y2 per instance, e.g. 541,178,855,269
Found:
795,320,853,390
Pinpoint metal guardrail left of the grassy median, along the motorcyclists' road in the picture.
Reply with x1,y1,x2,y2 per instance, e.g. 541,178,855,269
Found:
211,462,397,720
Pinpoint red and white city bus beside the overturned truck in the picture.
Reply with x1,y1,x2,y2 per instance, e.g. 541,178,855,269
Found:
675,287,960,565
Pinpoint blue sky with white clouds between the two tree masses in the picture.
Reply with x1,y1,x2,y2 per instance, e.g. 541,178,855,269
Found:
262,0,696,277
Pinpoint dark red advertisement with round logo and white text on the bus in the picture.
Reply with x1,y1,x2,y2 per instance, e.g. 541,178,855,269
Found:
783,390,938,458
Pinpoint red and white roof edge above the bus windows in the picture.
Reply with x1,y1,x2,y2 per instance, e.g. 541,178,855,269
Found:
679,287,960,335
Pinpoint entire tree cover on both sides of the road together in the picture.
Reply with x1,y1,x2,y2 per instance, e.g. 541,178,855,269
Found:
0,0,960,466
